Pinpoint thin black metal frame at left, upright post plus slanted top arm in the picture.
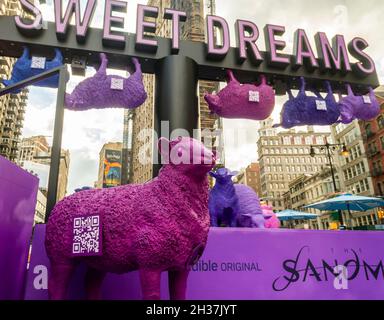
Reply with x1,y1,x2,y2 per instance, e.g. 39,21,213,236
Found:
0,65,68,222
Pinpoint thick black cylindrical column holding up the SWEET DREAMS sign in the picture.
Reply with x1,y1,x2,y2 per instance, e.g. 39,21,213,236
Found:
153,55,199,177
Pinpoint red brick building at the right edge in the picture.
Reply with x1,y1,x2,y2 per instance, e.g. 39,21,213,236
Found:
359,95,384,197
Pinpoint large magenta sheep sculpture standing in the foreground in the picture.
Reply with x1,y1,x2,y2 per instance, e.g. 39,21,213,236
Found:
45,137,215,300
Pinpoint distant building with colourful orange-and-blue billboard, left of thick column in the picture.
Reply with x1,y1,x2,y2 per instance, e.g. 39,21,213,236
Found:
95,142,123,189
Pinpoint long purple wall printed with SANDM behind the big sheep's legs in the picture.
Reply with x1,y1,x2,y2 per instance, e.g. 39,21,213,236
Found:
26,225,384,300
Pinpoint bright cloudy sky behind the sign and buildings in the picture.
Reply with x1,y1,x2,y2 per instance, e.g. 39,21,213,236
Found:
19,0,384,193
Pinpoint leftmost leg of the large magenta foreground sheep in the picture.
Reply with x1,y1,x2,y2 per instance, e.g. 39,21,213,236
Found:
48,263,75,300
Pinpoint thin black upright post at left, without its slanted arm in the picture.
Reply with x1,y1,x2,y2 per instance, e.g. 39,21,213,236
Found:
45,65,68,222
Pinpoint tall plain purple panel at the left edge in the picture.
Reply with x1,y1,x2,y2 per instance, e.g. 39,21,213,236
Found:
0,156,39,300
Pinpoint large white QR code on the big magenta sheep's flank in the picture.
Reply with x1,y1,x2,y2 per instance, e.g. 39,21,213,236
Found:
72,215,102,256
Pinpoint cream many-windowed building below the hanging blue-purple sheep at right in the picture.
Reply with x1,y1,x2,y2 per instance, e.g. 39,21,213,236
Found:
257,119,330,211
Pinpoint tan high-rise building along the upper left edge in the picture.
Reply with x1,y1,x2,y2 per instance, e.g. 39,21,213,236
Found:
0,0,28,162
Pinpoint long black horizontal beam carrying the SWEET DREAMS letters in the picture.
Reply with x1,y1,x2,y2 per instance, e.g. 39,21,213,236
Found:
0,16,379,93
